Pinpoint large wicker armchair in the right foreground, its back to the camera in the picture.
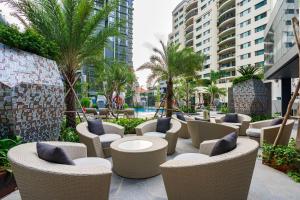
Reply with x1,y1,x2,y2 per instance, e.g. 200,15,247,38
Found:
161,138,258,200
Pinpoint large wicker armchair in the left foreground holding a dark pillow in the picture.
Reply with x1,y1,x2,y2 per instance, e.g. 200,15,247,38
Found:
8,142,112,200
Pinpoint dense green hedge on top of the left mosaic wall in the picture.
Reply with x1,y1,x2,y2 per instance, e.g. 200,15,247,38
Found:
0,22,59,60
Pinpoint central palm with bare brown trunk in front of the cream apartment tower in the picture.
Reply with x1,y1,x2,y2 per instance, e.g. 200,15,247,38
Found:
137,41,204,117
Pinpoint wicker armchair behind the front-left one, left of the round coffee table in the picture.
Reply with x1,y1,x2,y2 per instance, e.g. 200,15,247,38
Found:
76,122,124,158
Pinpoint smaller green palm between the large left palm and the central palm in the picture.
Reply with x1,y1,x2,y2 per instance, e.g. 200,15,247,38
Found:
96,61,136,115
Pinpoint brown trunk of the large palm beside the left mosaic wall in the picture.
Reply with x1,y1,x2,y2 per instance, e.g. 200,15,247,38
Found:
65,71,76,128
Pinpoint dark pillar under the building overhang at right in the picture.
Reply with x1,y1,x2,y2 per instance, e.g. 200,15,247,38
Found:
281,78,292,116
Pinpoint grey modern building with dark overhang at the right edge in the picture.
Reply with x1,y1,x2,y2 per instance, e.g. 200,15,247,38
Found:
264,0,299,114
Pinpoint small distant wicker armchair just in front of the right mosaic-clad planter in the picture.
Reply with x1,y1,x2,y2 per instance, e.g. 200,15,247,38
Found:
215,114,252,136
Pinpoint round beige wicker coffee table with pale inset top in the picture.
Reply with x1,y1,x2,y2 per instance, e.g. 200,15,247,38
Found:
110,136,168,178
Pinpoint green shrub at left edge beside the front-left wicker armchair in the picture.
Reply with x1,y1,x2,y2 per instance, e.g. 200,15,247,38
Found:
0,136,22,172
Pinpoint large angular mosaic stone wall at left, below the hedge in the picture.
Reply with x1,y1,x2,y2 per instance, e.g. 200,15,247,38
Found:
0,44,64,142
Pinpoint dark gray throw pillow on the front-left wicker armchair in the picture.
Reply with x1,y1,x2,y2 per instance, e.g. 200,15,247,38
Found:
36,142,75,165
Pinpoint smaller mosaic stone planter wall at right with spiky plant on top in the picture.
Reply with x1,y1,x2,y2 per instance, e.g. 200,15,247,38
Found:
229,79,271,115
